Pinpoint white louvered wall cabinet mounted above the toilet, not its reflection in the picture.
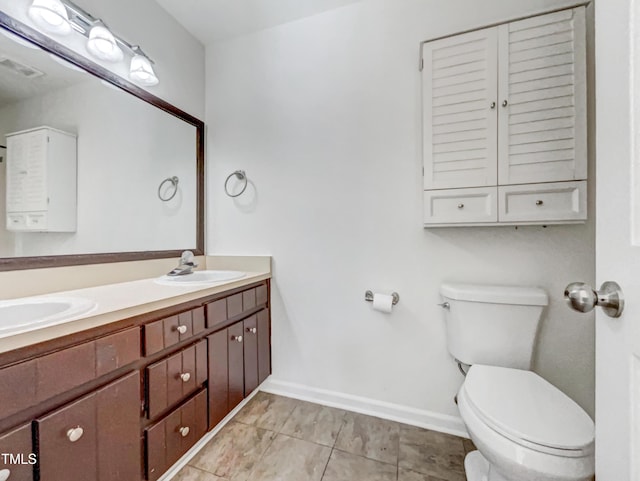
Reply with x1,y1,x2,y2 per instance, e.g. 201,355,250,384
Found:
422,7,587,227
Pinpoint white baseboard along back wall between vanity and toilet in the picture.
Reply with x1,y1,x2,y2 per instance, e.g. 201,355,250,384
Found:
260,376,469,438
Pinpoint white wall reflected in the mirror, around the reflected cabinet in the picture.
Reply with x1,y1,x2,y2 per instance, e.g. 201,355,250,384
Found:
0,79,197,257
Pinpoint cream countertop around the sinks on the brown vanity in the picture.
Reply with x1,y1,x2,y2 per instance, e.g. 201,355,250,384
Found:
0,258,271,352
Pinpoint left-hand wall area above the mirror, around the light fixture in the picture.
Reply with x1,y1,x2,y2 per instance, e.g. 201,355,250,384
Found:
0,0,204,118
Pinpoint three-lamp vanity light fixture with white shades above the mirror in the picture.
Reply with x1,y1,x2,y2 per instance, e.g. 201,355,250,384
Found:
29,0,160,87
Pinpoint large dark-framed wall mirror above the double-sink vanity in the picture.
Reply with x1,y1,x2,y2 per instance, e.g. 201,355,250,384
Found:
0,12,204,270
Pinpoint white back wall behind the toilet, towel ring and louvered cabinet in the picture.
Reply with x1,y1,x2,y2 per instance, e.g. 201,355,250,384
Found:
206,0,594,422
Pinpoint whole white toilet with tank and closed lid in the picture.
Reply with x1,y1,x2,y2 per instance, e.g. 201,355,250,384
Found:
440,284,594,481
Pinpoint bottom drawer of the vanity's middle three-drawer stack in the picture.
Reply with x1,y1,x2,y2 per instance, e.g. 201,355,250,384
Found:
145,389,207,481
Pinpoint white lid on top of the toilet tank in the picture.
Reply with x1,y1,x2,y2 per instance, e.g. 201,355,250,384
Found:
440,283,549,306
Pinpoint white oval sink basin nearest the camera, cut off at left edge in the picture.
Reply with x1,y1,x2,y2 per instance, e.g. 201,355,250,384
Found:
0,297,96,337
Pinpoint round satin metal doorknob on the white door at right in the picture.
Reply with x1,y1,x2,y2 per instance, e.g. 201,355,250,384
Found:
564,281,624,317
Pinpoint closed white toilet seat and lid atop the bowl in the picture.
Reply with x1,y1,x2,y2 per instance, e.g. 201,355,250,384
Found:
462,365,594,457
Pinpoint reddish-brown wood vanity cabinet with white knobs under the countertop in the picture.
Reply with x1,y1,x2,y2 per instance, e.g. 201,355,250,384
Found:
0,281,271,481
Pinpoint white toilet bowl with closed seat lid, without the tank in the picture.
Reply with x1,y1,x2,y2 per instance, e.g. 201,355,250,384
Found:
458,365,594,481
